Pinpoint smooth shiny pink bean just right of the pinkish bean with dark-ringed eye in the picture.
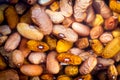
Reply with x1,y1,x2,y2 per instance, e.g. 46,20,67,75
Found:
72,22,90,36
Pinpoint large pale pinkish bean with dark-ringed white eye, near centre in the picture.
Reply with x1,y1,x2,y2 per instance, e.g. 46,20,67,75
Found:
53,25,78,42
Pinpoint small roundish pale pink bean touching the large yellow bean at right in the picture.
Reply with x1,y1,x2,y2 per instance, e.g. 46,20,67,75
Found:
99,32,113,44
